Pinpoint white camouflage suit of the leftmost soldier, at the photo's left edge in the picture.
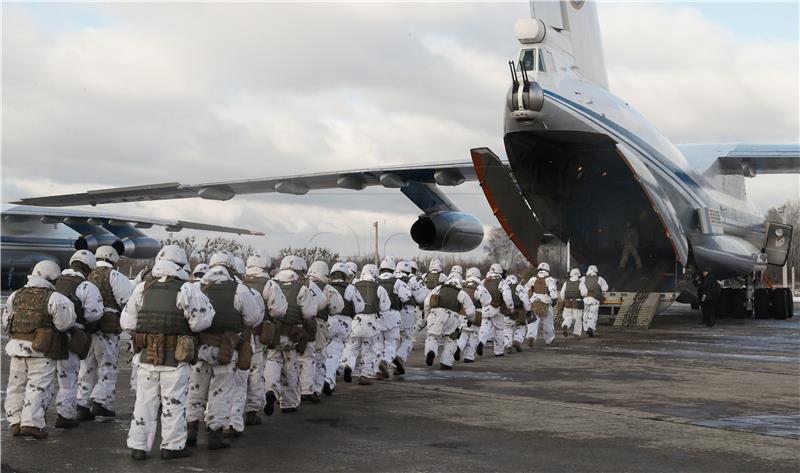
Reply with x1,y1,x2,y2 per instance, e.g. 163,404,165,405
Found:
2,276,75,429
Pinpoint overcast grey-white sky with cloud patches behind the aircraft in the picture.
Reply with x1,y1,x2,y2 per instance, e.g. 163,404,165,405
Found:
2,2,800,255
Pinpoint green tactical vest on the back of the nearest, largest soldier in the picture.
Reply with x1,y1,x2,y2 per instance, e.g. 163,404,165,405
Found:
136,278,192,335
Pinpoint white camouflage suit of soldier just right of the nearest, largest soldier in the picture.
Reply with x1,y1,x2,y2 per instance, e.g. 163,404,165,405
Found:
186,266,264,430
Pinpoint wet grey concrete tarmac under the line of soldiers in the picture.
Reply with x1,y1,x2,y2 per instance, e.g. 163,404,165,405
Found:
2,305,800,473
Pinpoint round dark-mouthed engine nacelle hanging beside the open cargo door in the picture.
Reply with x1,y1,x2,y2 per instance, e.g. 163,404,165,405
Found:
411,211,483,253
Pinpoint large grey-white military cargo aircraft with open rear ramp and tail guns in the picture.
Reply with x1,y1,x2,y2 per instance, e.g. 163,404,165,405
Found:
14,0,800,318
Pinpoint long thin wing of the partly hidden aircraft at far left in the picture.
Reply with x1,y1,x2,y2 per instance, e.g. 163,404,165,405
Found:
3,206,264,235
